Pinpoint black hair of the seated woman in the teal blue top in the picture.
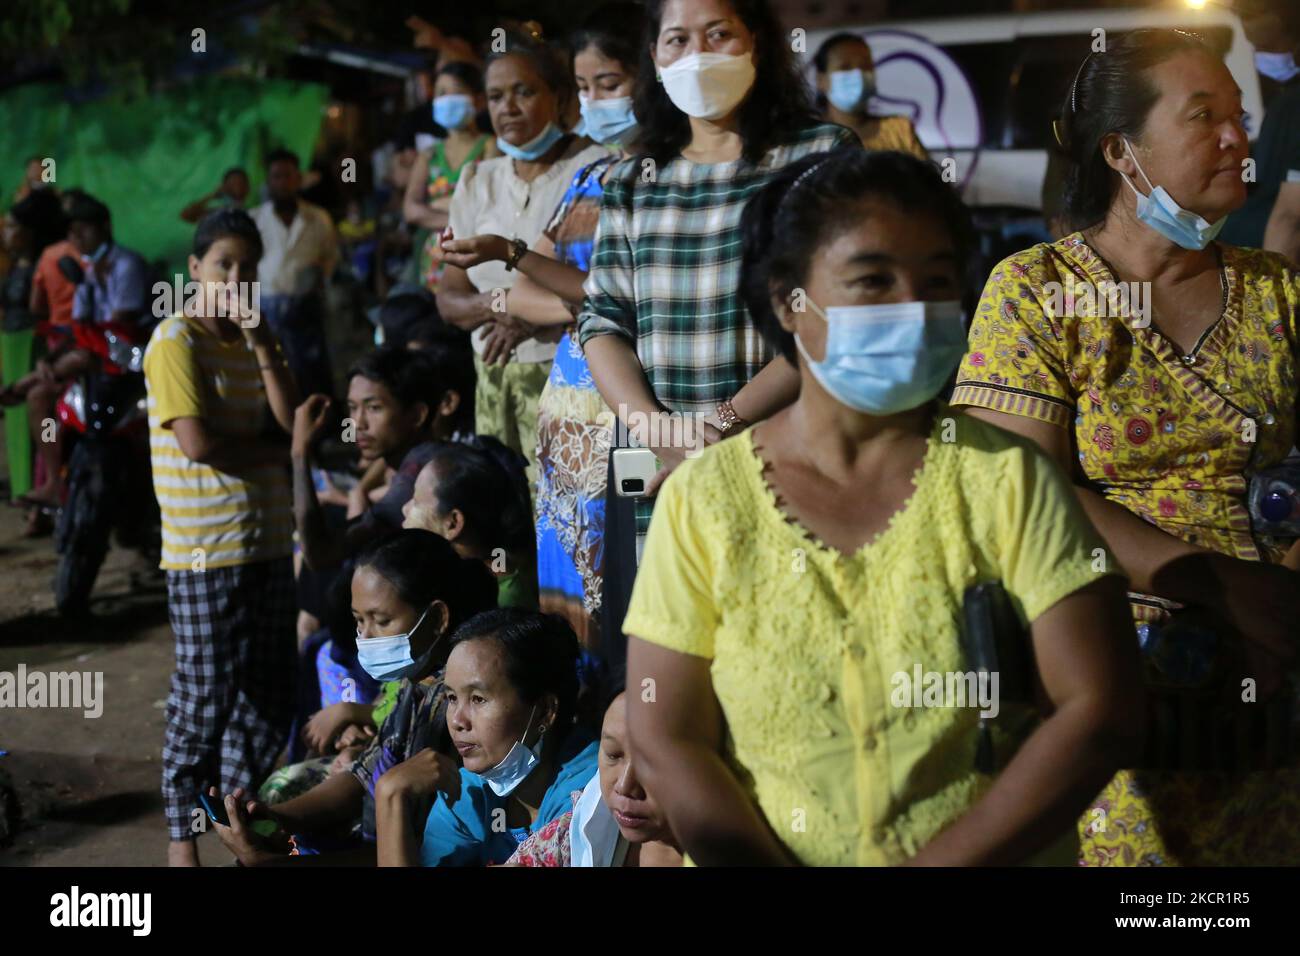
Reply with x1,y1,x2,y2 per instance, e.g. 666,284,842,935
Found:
451,607,579,744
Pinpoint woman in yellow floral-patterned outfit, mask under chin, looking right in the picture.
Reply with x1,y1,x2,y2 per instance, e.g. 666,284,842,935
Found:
953,30,1300,865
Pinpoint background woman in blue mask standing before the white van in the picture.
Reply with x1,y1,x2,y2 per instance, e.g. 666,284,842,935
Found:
813,34,930,159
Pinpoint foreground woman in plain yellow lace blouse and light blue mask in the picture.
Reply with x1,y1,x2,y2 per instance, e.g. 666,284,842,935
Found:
624,148,1144,865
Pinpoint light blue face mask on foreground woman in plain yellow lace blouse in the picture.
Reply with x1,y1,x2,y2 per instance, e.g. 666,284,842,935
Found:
794,299,966,415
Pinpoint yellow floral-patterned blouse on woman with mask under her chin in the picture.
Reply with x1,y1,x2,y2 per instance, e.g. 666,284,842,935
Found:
952,233,1300,606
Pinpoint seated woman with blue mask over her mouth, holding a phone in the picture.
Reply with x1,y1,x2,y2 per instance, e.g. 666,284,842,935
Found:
212,529,497,866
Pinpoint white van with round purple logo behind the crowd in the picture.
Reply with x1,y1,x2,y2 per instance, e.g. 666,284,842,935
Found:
806,5,1264,217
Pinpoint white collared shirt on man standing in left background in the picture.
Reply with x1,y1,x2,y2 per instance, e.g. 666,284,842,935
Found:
248,199,338,295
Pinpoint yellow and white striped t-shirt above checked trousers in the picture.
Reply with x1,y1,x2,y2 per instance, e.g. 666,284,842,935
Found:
144,315,293,571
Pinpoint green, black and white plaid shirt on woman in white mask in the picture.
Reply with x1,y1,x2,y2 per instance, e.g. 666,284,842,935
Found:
577,124,859,533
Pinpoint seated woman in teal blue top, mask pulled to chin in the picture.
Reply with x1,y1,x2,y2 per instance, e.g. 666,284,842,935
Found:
374,607,597,866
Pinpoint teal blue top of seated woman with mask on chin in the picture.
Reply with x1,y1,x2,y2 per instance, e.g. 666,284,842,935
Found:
420,730,598,866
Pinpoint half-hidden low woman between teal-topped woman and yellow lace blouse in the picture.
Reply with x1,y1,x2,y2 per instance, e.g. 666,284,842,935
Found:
506,691,681,866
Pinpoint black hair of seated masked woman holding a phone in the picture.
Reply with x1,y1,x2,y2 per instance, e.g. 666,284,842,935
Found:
352,528,497,630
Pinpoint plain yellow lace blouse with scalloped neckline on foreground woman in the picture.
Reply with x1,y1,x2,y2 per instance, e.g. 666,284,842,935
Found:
624,408,1100,866
